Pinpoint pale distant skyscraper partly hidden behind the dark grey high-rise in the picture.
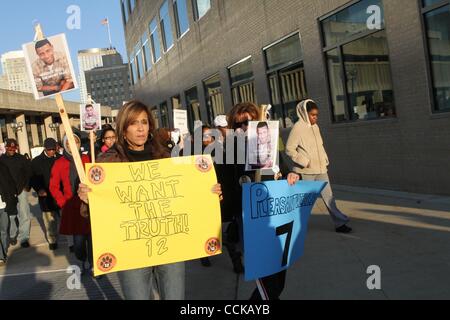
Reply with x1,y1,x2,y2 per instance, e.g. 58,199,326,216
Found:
78,48,117,103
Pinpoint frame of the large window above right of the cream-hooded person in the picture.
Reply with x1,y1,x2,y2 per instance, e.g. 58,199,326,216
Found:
317,0,398,125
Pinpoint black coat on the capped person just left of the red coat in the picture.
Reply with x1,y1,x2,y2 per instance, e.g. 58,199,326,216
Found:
30,151,61,212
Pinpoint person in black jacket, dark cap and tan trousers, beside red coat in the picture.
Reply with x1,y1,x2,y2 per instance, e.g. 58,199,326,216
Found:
30,138,61,251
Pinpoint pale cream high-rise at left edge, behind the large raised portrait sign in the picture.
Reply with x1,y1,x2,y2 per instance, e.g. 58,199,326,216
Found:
0,51,32,93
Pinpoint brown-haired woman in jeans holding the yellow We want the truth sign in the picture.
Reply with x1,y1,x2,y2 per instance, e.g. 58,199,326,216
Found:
78,101,222,300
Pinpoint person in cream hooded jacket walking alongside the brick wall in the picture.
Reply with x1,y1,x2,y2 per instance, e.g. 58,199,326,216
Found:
286,99,352,233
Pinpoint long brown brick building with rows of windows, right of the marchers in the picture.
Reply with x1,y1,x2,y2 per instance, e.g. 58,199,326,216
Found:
119,0,450,195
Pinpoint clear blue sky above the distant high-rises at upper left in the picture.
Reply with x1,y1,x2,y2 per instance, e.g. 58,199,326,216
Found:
0,0,128,101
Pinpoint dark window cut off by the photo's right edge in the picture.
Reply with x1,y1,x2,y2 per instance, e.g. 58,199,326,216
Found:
423,0,450,112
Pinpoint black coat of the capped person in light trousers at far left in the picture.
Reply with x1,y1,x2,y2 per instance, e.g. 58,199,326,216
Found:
0,153,32,194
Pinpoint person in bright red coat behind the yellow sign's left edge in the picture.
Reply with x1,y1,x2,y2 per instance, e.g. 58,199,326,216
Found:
50,135,93,273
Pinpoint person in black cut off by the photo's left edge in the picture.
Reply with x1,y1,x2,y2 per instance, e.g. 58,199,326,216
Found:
0,162,17,266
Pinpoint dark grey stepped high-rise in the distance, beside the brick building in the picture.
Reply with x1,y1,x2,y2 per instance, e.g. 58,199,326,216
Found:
85,53,131,109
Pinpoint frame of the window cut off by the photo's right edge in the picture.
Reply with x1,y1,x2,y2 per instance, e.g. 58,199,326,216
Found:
417,0,450,115
